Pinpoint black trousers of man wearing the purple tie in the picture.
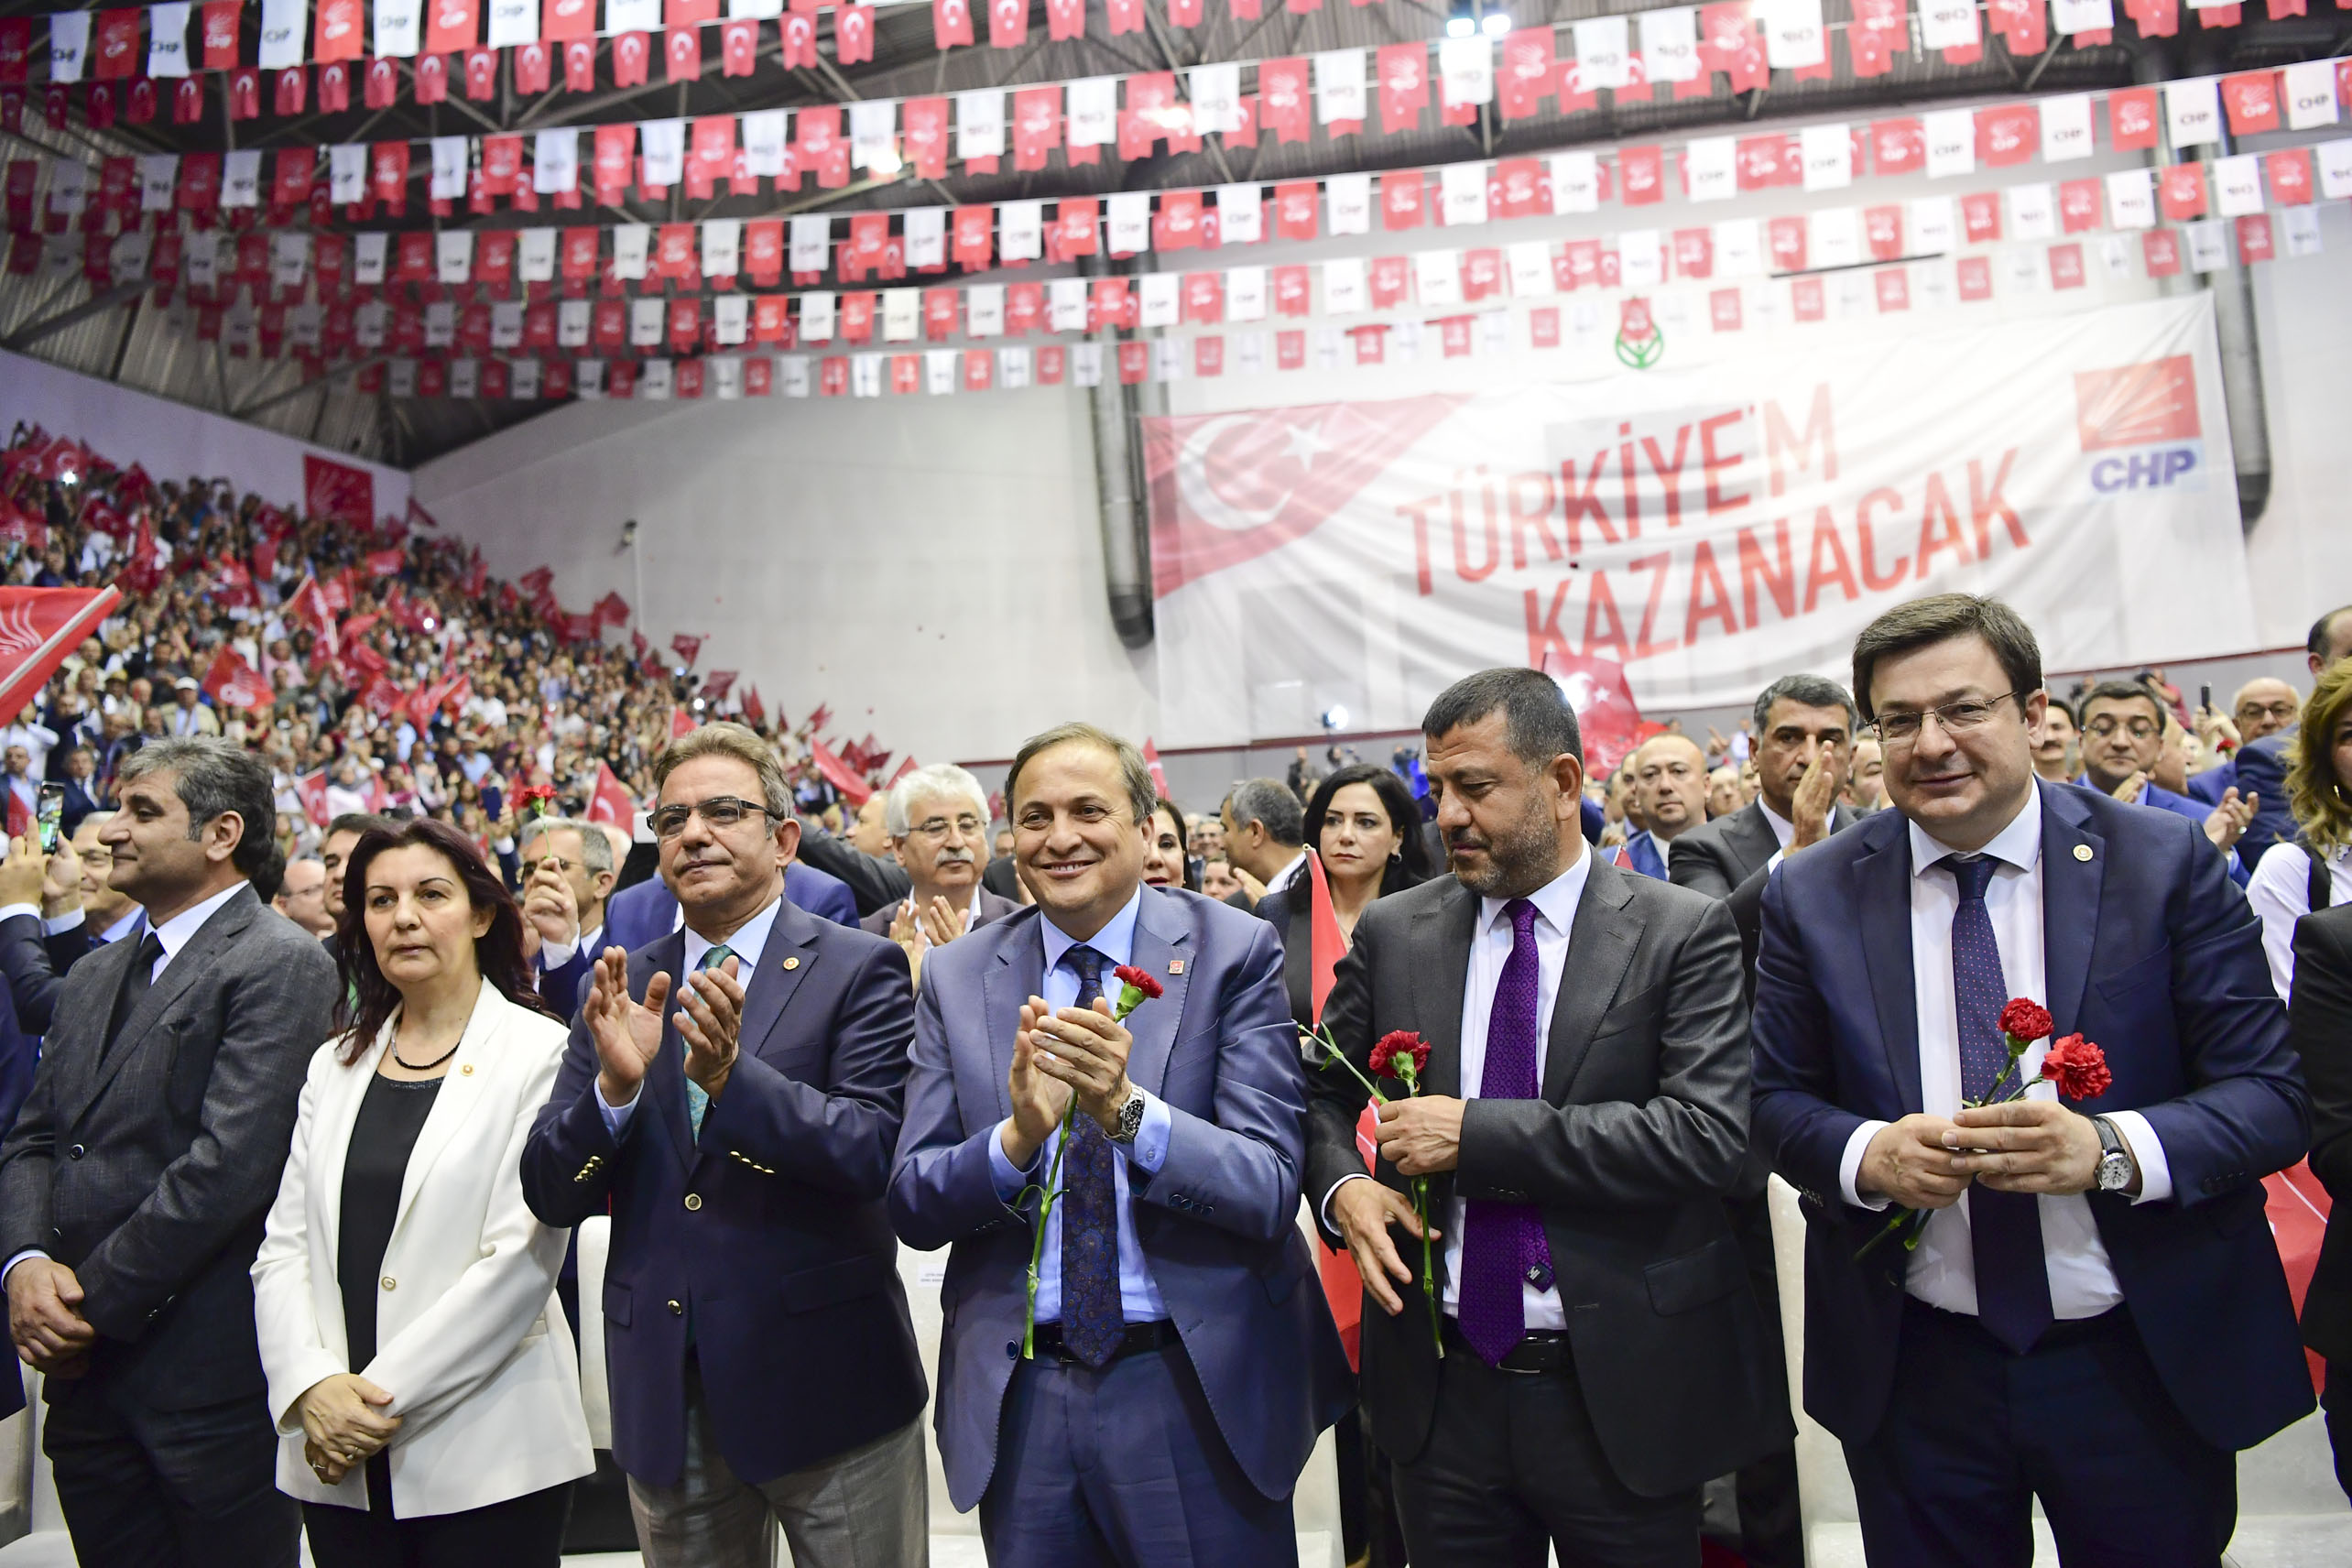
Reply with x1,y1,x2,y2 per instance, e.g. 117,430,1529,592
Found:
1395,1335,1698,1568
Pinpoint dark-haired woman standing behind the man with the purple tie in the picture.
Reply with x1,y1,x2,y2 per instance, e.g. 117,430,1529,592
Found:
1258,762,1430,1568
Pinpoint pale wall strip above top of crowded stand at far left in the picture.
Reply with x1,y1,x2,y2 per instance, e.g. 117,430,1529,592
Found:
0,353,409,517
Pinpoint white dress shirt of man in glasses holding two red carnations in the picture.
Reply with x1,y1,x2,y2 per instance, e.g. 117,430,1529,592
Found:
1837,783,2173,1319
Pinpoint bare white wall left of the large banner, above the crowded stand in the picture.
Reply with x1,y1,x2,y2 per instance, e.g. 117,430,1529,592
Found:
417,376,1155,762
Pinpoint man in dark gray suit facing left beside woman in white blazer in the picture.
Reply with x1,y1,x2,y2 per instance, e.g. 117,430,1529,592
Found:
0,735,339,1568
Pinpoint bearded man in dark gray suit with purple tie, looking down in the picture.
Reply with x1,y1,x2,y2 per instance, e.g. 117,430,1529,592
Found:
1308,670,1792,1568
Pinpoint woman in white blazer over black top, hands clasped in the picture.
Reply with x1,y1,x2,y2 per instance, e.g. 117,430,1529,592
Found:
254,821,595,1568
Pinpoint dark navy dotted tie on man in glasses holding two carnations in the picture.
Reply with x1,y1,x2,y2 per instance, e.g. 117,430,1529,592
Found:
1938,855,2051,1354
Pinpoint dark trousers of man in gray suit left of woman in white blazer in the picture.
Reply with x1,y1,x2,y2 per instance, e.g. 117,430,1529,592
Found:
40,1373,301,1568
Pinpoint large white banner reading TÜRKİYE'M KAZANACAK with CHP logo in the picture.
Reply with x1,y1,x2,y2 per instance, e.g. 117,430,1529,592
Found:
1143,294,2256,746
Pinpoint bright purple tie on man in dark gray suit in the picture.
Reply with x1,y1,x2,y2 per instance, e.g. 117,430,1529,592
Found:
1458,898,1552,1366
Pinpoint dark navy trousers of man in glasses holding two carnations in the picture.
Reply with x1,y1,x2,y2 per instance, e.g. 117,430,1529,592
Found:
1846,1300,2237,1568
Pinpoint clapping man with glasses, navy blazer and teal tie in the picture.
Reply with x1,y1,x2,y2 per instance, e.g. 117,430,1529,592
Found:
522,724,929,1568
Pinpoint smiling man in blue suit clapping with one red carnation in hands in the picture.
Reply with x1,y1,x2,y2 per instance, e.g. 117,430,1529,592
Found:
891,724,1353,1568
